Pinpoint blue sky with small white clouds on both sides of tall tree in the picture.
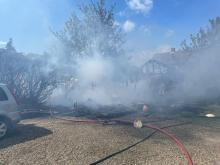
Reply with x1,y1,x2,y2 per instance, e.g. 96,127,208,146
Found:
0,0,220,53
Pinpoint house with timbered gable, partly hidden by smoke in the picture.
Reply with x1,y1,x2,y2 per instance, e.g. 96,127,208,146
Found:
141,48,191,95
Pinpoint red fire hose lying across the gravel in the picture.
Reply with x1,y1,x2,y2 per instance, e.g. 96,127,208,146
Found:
53,116,193,165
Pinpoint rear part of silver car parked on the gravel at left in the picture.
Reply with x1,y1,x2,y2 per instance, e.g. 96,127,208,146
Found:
0,84,20,139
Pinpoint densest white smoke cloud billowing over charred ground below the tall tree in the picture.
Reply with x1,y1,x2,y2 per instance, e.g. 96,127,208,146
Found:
48,50,152,105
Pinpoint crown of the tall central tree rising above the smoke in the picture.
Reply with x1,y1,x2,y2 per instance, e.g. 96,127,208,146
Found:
54,0,123,58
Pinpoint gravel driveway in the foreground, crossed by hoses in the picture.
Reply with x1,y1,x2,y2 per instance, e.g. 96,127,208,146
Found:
0,116,220,165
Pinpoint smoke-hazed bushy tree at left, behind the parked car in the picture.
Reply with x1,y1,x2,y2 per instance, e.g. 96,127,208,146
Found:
0,40,55,105
